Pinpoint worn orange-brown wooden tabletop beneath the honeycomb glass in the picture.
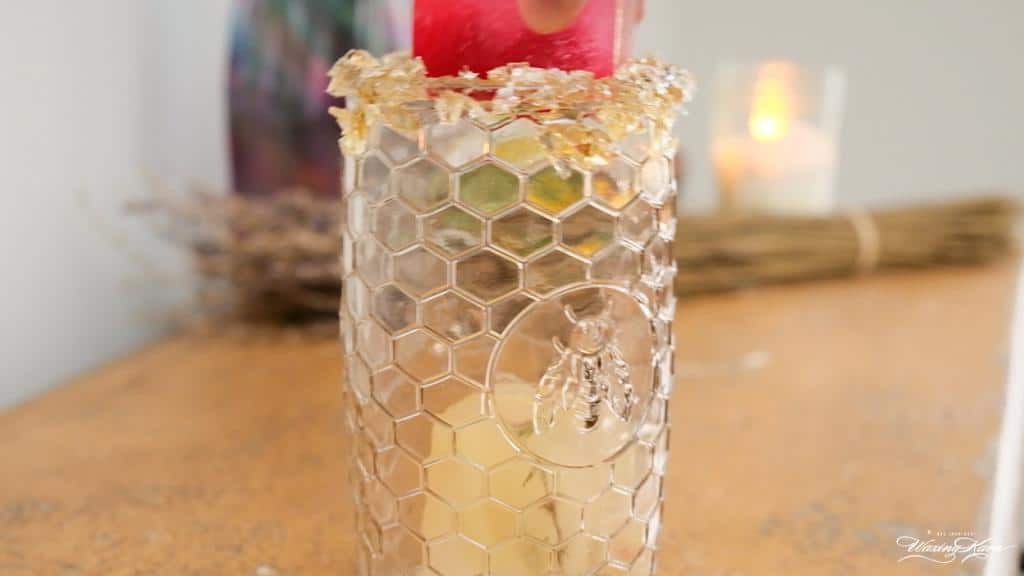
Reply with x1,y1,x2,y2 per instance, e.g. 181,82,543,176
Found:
0,265,1016,576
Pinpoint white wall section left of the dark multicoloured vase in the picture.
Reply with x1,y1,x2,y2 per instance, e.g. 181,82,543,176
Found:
0,0,226,406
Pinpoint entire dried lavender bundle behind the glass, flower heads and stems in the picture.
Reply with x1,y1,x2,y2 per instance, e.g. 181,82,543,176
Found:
133,191,1019,334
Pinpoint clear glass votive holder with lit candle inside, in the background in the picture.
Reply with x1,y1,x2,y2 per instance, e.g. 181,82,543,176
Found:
712,60,845,214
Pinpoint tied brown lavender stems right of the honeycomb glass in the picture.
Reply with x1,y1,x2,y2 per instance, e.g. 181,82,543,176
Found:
675,196,1020,296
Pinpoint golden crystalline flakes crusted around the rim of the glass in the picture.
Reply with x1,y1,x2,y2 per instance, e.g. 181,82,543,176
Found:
328,50,693,170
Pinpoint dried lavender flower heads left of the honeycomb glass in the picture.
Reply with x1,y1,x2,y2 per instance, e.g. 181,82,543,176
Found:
130,190,341,333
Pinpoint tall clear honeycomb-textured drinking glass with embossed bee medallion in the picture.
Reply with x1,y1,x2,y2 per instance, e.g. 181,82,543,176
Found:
336,50,692,576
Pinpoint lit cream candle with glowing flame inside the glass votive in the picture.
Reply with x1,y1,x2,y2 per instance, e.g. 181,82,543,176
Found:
713,63,837,214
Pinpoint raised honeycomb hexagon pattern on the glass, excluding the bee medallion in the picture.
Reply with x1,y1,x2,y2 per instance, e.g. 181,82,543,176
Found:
342,113,676,576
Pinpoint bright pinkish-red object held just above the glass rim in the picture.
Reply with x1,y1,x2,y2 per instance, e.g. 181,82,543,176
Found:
413,0,638,76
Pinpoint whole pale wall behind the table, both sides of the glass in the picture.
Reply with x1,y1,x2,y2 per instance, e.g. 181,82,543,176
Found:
0,0,1024,406
